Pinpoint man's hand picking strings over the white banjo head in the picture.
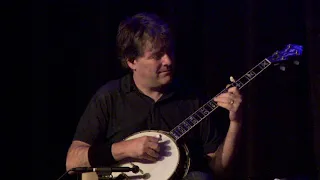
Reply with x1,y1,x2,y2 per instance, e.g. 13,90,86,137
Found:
112,136,160,161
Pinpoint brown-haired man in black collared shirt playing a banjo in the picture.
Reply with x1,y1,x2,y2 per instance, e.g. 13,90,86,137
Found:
66,13,242,179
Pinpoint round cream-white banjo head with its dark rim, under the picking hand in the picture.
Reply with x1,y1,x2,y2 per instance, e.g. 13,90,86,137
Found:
82,130,190,180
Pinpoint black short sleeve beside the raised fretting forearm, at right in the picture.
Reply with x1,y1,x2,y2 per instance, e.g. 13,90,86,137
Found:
200,108,229,154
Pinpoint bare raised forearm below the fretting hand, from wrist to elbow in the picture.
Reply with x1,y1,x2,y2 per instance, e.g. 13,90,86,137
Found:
207,122,241,176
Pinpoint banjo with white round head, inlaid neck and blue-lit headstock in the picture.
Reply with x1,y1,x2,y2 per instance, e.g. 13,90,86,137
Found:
82,44,303,180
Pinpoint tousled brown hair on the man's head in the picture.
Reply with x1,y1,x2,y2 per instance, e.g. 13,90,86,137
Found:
117,13,172,68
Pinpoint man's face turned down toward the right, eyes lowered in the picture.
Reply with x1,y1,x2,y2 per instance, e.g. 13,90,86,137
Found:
127,46,173,88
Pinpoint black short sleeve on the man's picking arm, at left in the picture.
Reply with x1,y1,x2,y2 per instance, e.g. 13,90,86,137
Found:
73,94,108,145
